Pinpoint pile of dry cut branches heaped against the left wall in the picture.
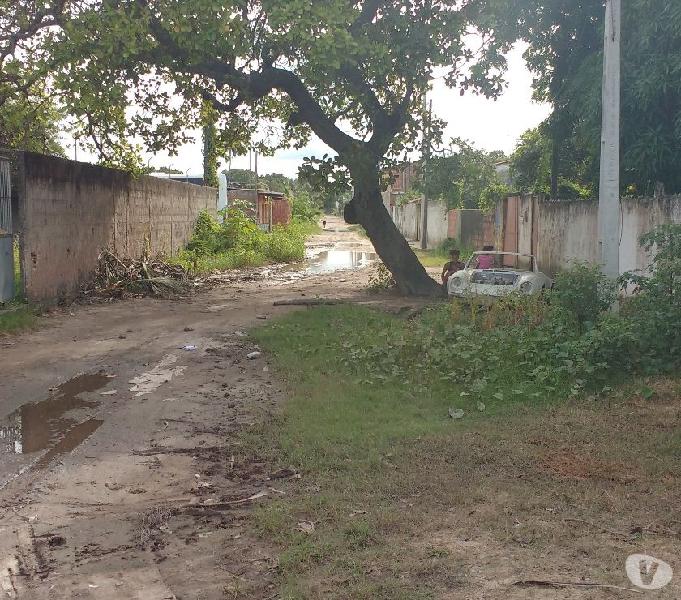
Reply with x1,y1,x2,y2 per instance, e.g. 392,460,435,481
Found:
82,250,193,299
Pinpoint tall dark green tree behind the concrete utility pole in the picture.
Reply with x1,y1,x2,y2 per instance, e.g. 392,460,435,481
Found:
499,0,681,196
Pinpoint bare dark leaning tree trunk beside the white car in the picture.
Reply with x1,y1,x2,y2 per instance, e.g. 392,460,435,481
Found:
345,167,444,297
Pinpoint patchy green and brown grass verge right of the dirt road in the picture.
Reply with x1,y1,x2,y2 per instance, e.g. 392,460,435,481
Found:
249,307,681,600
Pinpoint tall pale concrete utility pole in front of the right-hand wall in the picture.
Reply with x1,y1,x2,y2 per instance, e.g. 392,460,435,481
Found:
598,0,622,279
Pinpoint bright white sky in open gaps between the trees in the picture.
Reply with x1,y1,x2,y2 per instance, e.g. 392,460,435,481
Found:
64,45,550,177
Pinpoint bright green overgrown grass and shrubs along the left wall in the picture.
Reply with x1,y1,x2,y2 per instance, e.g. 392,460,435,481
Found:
170,209,319,274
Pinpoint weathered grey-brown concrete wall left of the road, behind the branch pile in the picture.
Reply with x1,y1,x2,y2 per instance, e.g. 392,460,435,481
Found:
15,153,217,301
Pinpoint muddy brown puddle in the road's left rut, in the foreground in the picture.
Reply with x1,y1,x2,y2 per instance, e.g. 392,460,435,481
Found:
0,373,111,468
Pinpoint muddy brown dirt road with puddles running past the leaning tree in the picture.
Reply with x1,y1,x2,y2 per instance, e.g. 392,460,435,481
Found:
0,218,398,600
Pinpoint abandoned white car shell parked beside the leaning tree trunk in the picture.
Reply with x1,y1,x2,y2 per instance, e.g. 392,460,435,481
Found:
447,252,553,298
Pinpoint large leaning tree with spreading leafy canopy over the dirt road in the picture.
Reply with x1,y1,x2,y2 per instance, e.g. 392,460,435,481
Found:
14,0,504,295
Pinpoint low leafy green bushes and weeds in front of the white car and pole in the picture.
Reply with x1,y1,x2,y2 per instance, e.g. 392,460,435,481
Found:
338,226,681,406
